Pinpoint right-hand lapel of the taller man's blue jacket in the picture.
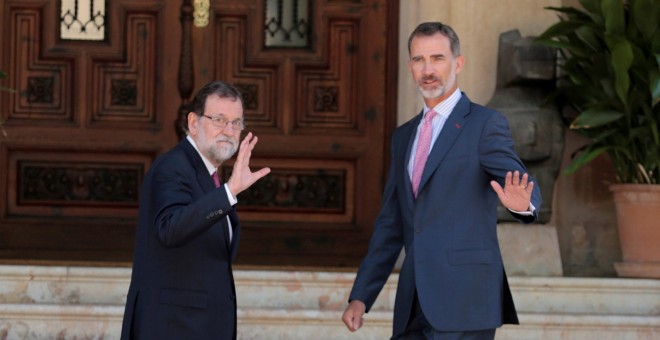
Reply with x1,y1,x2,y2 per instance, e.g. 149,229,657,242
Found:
418,94,470,197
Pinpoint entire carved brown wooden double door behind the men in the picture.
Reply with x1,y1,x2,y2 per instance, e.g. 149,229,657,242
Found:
0,0,398,266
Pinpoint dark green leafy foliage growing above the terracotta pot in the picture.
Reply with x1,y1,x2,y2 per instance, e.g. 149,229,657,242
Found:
542,0,660,183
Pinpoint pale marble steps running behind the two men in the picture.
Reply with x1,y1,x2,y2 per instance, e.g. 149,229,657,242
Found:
0,266,660,340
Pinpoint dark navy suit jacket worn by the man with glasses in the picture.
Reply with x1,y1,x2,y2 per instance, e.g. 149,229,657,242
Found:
121,139,240,340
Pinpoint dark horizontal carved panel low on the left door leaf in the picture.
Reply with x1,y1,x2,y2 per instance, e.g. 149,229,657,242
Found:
2,147,154,218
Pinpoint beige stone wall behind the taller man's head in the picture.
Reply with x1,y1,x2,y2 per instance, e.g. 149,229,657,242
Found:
398,0,562,124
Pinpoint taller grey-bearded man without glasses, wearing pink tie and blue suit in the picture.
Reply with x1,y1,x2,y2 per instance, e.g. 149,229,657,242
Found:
342,22,541,339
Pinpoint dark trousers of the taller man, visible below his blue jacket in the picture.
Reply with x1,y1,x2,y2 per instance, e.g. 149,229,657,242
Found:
391,289,495,340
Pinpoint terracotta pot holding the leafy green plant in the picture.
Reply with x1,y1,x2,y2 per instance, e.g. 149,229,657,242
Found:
610,184,660,278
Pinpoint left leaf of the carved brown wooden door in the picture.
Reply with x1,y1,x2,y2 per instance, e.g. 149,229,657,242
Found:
0,0,180,261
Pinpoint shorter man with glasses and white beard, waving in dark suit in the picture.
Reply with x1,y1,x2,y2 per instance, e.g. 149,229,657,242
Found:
121,81,270,340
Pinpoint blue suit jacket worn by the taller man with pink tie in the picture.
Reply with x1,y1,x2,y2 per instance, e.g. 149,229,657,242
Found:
350,94,541,335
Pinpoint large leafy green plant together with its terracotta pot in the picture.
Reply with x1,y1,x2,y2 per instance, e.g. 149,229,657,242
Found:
538,0,660,278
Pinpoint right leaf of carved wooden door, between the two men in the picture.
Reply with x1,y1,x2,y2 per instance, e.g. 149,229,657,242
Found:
208,1,396,266
